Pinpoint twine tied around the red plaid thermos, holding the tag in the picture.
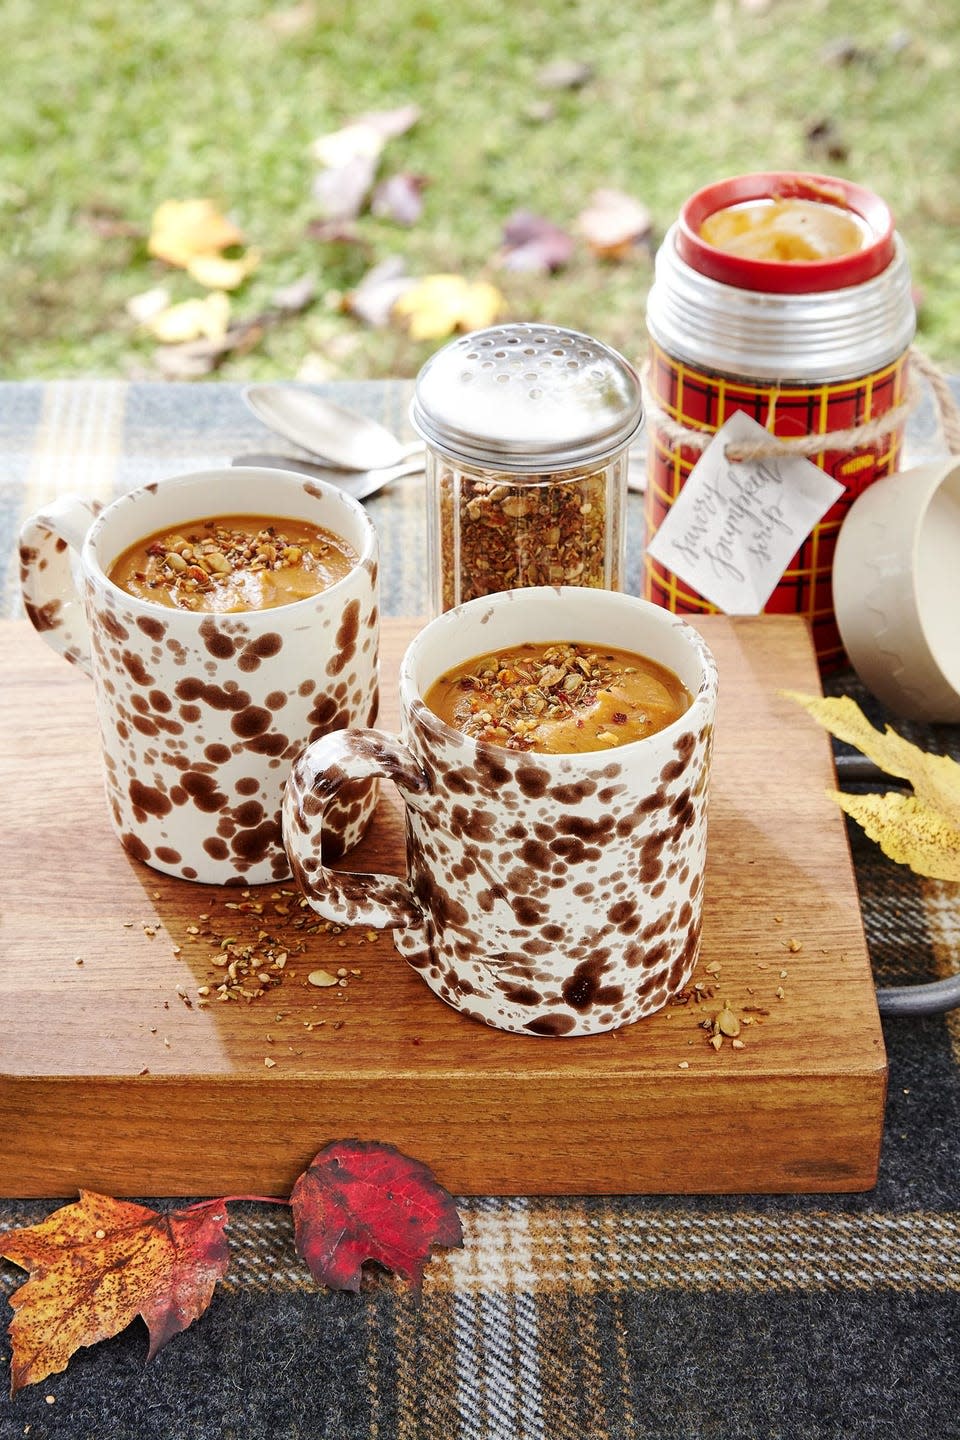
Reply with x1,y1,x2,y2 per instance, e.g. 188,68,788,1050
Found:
640,346,960,461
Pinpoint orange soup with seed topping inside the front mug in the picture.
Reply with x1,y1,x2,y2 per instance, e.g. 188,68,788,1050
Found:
425,641,691,755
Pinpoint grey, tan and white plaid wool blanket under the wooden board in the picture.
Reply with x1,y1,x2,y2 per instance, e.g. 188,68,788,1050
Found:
0,382,960,1440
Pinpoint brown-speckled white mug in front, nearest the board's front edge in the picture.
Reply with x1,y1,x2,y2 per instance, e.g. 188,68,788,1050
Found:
284,588,717,1035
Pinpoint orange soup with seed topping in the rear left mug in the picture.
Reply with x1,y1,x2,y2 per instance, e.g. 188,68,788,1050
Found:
109,516,357,615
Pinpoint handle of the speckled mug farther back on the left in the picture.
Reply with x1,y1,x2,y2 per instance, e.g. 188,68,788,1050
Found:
20,495,104,675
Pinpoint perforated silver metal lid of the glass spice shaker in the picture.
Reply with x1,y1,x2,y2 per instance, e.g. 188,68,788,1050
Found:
410,324,643,474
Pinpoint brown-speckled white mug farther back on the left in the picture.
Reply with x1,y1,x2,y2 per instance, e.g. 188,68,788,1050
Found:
20,467,379,884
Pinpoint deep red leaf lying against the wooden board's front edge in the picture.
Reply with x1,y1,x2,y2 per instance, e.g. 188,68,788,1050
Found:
291,1140,463,1290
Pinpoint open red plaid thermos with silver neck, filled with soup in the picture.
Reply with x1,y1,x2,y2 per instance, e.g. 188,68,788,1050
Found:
643,173,915,668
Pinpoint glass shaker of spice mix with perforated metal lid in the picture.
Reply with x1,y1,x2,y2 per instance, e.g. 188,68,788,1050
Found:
410,324,643,615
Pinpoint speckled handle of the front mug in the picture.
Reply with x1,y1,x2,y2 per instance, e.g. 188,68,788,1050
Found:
284,730,429,929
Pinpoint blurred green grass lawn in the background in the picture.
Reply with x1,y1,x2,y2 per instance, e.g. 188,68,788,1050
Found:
0,0,960,379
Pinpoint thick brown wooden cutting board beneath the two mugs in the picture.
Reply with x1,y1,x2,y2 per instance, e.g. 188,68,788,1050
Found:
0,616,887,1197
